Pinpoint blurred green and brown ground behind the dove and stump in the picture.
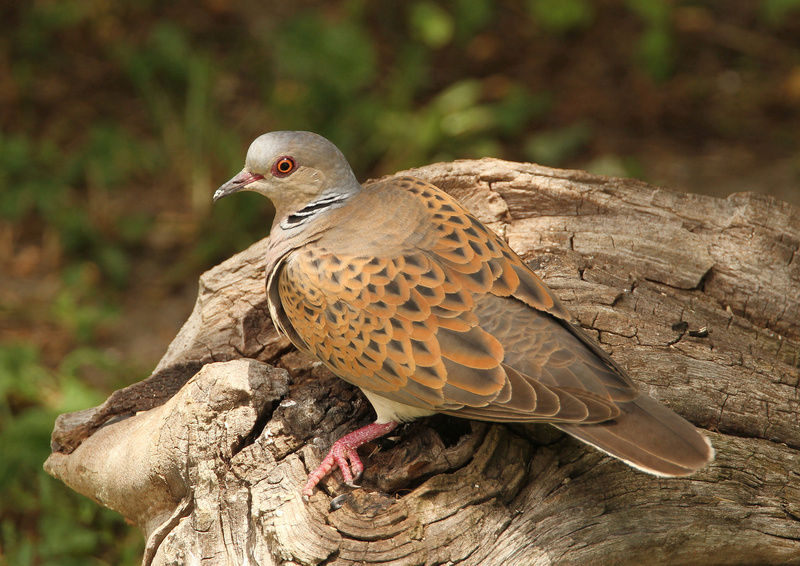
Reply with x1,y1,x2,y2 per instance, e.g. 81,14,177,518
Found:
0,0,800,566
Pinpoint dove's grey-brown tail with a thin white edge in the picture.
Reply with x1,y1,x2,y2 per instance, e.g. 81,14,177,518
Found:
554,395,714,477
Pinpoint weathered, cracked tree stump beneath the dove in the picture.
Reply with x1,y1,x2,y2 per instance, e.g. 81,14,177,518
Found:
45,159,800,566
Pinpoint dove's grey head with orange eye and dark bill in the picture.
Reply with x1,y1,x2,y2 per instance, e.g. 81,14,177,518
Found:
214,132,361,221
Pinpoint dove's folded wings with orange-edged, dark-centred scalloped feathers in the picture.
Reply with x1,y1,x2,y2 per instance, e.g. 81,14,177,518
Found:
270,178,636,422
